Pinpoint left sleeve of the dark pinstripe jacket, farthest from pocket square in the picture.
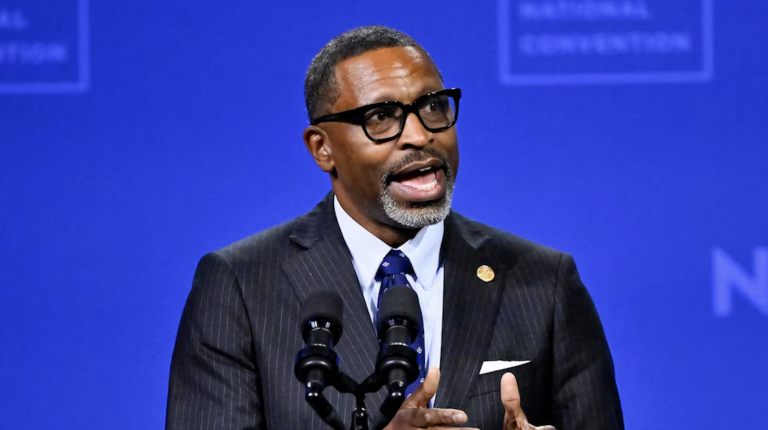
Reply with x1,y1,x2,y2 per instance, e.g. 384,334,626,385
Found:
166,253,264,430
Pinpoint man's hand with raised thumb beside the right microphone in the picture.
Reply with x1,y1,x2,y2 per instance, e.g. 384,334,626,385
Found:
384,367,477,430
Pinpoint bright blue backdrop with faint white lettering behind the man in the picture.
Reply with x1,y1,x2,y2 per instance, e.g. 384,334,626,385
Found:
0,0,768,430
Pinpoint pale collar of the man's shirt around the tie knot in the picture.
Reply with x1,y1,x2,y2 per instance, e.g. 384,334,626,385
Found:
333,196,445,290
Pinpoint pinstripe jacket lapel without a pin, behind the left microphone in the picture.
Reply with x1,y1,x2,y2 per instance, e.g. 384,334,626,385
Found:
283,194,383,409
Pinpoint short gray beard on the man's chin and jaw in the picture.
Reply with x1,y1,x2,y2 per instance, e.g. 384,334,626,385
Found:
379,164,454,228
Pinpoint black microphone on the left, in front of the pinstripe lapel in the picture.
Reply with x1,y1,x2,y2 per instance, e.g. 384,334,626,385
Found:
294,291,344,430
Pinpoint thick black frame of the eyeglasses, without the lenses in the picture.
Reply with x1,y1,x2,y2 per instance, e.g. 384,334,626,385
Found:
310,88,461,143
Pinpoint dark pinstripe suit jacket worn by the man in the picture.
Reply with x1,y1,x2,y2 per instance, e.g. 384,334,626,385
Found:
166,194,623,430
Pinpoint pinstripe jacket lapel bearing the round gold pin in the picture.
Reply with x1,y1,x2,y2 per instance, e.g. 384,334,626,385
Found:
435,212,506,409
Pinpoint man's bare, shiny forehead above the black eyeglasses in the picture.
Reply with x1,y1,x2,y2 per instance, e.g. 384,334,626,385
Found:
335,46,442,109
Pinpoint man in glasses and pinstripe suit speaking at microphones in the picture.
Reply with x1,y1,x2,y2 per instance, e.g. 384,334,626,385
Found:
166,26,623,430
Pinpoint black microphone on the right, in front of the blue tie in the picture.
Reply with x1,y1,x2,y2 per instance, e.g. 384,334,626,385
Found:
376,285,421,419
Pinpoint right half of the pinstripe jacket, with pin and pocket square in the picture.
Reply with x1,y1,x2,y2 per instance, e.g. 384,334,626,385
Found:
436,218,624,430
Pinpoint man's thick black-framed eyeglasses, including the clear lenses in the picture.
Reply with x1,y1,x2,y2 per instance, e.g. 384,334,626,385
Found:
311,88,461,143
